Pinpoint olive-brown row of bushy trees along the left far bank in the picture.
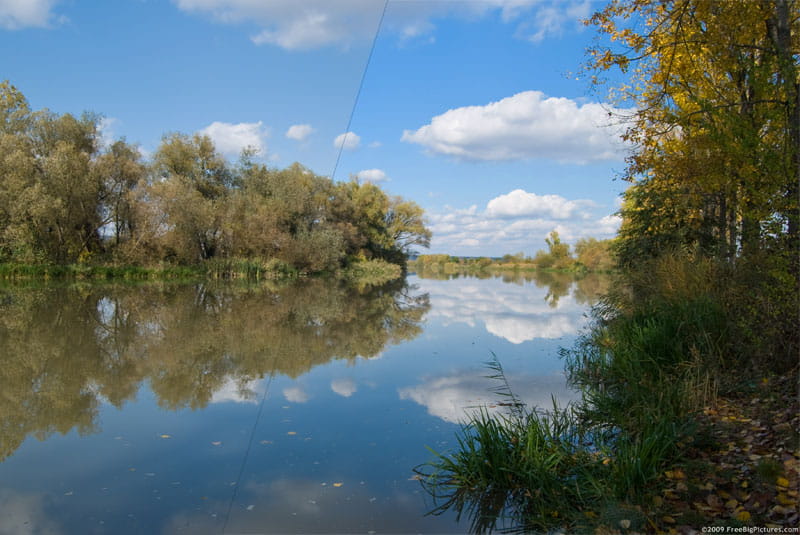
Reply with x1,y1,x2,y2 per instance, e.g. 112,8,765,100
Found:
0,81,431,272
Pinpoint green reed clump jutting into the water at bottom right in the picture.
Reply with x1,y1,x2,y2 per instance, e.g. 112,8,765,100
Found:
418,404,609,533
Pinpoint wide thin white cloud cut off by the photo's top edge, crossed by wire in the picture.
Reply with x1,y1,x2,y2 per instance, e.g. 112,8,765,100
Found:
172,0,589,51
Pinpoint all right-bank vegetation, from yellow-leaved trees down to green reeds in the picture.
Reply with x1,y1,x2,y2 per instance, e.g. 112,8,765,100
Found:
418,0,800,533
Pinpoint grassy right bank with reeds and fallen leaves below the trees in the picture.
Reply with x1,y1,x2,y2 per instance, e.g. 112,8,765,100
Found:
420,257,800,532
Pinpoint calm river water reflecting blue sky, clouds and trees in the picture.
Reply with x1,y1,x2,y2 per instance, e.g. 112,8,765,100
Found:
0,275,603,535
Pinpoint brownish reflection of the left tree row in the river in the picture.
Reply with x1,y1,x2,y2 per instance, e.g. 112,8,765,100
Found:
0,281,430,460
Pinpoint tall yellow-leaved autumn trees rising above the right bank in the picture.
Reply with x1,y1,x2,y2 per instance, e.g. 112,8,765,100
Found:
589,0,800,262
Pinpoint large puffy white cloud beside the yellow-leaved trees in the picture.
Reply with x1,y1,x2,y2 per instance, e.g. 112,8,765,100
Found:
402,91,624,164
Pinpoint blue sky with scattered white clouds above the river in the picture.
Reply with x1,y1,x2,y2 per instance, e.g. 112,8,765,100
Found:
0,0,626,256
